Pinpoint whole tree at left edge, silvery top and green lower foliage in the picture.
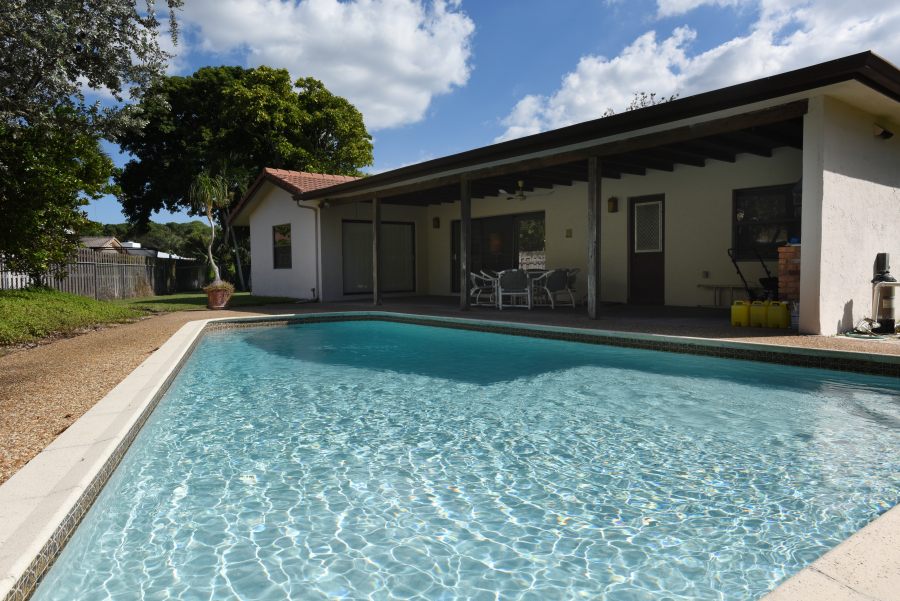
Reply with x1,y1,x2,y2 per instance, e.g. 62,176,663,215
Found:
0,0,182,274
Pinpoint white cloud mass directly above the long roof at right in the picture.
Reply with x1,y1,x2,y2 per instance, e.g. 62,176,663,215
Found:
496,0,900,141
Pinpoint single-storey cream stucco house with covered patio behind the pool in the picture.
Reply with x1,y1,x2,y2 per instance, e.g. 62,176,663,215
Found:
230,52,900,334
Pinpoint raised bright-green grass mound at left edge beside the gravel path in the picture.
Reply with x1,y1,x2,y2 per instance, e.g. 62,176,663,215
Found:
0,290,144,345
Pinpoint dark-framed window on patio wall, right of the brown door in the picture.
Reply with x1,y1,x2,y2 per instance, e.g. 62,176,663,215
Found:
732,184,800,260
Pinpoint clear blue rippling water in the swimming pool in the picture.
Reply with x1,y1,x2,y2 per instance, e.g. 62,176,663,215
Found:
35,322,900,601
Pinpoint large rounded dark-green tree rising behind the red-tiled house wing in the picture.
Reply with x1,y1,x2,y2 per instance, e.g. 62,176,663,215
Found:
117,67,372,223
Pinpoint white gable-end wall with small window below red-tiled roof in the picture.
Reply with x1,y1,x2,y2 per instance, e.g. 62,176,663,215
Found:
249,184,319,299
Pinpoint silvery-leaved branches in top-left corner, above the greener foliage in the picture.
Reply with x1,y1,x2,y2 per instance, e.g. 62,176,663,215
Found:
0,0,182,135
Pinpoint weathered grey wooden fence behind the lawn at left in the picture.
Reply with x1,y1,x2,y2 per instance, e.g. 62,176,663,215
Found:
0,248,205,300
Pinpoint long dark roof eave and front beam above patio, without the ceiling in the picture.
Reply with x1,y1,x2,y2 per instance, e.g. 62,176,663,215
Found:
299,52,900,202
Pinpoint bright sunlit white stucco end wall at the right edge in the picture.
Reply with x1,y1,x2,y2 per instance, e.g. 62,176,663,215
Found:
800,97,900,334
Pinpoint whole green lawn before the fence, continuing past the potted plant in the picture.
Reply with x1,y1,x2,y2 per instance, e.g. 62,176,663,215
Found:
0,290,294,346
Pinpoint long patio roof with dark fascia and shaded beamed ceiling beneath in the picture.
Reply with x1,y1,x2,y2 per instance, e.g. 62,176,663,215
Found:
288,52,900,204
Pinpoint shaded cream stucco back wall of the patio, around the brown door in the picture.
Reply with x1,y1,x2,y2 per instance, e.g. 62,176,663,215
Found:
428,148,802,306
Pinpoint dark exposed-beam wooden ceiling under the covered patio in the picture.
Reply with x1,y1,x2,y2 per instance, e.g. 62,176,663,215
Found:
378,117,803,206
